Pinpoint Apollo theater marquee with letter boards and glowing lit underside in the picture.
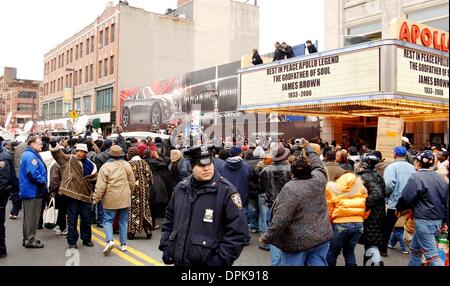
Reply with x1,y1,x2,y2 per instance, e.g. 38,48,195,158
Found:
238,19,449,151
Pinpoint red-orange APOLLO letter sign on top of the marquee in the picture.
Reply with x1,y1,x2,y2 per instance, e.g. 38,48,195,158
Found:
391,18,449,52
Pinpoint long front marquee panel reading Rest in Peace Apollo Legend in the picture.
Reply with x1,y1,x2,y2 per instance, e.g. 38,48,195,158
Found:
241,48,380,105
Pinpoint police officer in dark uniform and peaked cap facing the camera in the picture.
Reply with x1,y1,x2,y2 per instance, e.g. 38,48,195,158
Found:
159,145,248,266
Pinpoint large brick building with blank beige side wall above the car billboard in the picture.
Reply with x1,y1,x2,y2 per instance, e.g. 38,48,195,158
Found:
39,0,259,133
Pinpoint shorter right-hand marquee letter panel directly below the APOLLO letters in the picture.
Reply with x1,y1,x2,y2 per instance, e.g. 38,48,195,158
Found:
397,48,449,99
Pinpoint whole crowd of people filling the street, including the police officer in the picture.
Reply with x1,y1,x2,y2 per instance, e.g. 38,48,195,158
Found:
0,130,449,266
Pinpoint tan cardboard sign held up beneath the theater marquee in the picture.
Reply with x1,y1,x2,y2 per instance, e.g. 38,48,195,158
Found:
376,117,405,161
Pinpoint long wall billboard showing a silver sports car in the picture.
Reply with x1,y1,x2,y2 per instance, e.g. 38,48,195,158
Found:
120,62,240,130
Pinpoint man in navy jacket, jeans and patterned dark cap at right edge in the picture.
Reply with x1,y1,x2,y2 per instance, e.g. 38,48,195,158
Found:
397,150,448,266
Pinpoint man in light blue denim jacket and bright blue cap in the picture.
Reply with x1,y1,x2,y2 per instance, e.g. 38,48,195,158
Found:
380,146,416,255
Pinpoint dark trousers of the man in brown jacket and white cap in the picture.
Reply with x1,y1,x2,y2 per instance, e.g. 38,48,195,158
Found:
67,197,92,244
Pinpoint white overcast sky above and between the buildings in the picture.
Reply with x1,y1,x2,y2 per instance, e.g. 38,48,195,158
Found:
0,0,324,80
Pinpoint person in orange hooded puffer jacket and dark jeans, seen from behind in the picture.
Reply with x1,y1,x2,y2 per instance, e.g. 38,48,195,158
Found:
326,172,367,266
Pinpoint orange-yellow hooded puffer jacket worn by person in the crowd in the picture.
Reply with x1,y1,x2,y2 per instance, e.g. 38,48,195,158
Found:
326,173,367,223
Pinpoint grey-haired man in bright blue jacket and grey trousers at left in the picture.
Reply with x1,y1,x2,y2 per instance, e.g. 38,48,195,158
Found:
19,136,48,248
